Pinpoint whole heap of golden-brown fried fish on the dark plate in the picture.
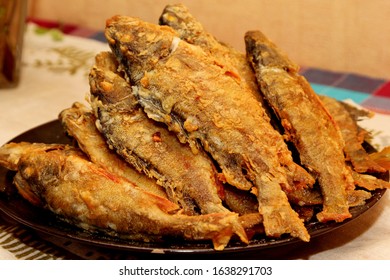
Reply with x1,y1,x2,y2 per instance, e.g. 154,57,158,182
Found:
0,4,390,250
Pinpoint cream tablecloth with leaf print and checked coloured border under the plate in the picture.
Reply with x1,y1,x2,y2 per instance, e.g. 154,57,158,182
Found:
0,20,390,259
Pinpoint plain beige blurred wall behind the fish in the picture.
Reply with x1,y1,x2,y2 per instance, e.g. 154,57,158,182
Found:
29,0,390,79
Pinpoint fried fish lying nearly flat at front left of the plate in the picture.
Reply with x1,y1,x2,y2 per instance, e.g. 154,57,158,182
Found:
0,142,247,250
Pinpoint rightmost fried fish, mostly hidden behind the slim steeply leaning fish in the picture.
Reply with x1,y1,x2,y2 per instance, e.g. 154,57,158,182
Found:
320,96,386,173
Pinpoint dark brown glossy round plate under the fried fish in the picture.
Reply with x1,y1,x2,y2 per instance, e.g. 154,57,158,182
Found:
0,120,385,254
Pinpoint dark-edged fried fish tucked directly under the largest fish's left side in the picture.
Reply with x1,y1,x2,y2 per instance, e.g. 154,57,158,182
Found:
90,53,229,214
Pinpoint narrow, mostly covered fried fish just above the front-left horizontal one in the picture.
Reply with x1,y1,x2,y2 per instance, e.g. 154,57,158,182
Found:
59,102,263,236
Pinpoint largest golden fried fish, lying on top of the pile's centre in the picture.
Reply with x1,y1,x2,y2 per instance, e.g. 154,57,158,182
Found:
105,16,309,241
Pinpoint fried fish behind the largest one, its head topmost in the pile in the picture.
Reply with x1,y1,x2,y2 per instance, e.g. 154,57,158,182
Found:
159,4,314,190
